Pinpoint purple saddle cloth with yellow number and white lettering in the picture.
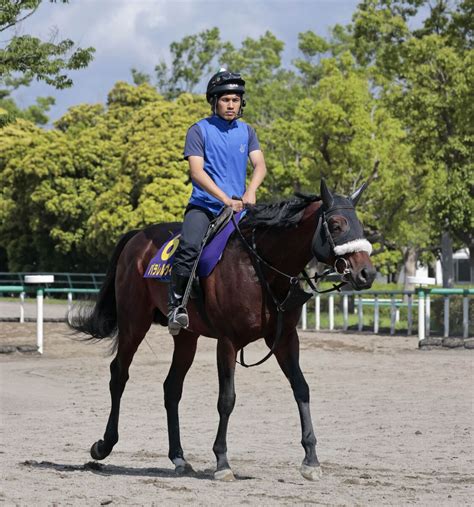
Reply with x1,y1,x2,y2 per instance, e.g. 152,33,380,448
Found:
143,210,245,281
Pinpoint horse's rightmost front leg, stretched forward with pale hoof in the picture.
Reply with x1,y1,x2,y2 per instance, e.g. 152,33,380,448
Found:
267,329,321,481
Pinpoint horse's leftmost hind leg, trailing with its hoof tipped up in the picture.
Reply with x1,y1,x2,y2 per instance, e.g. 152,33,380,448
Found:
91,306,152,460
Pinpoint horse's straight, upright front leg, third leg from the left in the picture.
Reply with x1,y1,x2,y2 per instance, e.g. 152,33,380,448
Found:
213,338,237,481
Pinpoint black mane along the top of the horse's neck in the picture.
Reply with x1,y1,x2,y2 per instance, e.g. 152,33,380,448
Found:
242,192,321,228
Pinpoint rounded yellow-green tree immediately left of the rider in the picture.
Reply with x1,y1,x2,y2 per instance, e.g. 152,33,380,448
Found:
87,85,208,254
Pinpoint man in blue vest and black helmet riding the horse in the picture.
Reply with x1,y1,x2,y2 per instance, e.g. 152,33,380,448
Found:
168,69,267,335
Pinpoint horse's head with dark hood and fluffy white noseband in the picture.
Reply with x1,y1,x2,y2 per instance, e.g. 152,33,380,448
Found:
311,180,375,290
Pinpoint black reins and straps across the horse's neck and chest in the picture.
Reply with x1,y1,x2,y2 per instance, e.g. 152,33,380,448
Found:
232,210,348,368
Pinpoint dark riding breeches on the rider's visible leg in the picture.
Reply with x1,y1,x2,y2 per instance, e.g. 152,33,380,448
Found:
173,204,214,276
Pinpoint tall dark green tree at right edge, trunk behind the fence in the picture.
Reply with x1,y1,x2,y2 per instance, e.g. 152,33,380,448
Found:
352,0,474,285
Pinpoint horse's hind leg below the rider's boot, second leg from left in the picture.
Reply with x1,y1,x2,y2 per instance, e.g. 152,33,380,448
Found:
163,329,199,473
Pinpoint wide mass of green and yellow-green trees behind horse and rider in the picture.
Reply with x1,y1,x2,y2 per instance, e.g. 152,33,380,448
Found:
0,5,474,280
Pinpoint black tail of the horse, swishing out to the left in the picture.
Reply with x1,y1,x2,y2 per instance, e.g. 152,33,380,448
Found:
67,230,139,339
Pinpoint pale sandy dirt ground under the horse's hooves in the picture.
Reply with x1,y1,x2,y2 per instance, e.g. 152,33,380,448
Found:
0,323,474,506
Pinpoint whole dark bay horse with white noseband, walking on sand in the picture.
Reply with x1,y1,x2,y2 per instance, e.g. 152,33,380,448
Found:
72,182,375,480
